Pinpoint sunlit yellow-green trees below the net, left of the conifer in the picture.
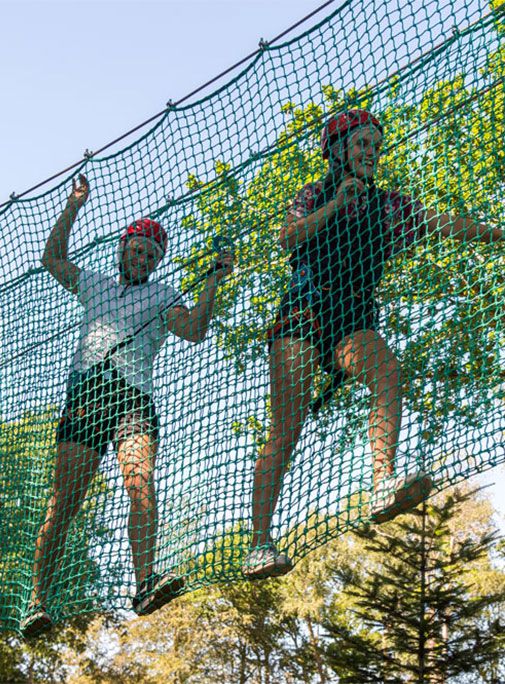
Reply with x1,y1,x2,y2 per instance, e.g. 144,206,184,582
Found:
63,582,314,684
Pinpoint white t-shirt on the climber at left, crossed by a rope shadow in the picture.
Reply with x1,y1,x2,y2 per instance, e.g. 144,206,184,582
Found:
70,270,182,394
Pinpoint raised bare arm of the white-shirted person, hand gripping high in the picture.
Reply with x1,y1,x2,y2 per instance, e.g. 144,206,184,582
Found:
42,174,89,294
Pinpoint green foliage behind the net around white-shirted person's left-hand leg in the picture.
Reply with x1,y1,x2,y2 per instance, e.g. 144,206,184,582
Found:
0,409,107,630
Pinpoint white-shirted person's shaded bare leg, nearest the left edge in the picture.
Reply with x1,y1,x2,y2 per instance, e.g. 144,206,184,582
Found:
32,442,100,604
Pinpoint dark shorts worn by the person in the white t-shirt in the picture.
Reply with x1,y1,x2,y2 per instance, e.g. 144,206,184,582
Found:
56,369,159,456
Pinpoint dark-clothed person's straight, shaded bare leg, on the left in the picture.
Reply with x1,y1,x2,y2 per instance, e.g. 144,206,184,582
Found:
253,338,319,546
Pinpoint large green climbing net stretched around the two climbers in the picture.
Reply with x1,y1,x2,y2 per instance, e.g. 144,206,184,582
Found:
0,0,505,629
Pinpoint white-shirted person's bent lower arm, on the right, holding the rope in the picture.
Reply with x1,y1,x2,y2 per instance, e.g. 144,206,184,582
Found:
163,252,233,342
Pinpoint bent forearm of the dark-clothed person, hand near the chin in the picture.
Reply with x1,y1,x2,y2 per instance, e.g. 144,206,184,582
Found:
279,176,365,252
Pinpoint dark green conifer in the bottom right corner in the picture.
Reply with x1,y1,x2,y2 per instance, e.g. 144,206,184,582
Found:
320,490,505,684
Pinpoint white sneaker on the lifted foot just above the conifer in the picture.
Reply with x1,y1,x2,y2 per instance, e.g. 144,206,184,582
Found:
370,470,433,524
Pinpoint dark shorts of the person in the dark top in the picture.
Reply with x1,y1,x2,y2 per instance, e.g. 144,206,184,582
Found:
267,293,378,372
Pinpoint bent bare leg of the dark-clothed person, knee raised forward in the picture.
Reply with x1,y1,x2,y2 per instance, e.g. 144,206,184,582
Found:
335,330,402,485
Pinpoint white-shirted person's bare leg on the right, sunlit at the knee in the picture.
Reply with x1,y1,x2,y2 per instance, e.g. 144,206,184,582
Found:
118,434,158,587
